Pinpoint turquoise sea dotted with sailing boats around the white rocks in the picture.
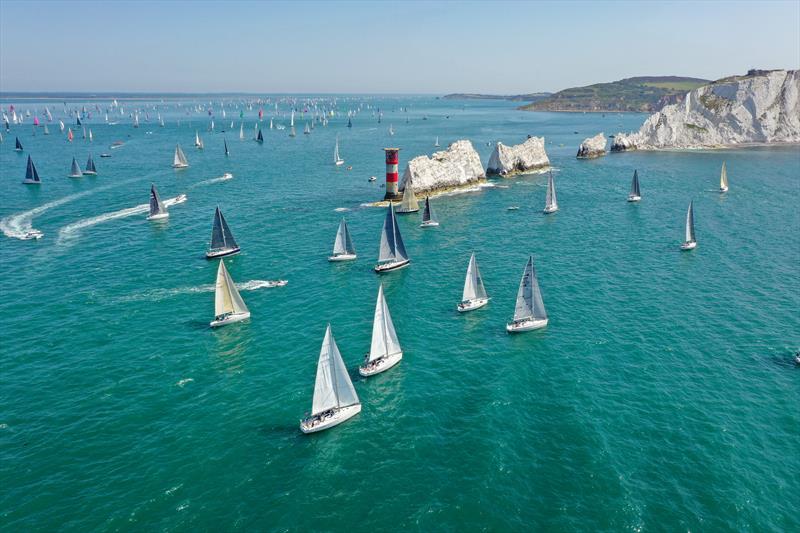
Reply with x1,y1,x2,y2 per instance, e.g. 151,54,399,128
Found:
0,96,800,532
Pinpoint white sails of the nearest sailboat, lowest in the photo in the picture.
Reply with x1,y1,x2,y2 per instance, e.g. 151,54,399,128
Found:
311,324,359,415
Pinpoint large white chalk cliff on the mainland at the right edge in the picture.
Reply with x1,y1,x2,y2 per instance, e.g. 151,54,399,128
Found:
611,70,800,152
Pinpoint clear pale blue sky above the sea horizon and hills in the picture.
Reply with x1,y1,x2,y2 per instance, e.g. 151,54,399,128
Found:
0,0,800,94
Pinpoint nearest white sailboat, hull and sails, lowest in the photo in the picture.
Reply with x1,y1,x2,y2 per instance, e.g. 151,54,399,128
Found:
300,324,361,433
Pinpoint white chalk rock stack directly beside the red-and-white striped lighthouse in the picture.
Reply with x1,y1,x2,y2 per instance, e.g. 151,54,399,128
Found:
400,140,486,195
